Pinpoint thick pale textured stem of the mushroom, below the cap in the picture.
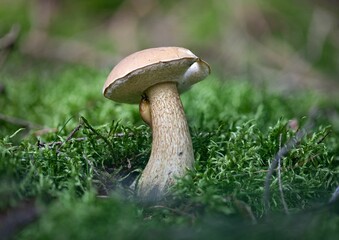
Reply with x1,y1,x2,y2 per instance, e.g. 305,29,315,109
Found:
138,82,194,201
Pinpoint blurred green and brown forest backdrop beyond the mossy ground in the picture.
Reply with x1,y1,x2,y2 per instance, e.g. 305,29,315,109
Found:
0,0,339,95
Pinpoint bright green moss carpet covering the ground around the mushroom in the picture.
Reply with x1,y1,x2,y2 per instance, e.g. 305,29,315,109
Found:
0,53,339,239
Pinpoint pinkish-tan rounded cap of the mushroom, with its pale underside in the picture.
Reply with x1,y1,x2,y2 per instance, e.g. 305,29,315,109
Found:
103,47,210,103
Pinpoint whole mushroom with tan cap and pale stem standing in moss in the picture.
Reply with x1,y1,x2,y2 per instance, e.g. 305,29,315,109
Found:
103,47,210,201
